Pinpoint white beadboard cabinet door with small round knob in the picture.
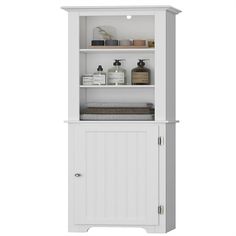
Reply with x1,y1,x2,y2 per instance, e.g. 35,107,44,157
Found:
71,124,158,225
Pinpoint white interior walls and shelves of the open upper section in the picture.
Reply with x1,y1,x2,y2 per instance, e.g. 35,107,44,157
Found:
79,14,156,121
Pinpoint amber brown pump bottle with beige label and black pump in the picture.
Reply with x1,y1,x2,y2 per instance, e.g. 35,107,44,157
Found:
131,59,151,85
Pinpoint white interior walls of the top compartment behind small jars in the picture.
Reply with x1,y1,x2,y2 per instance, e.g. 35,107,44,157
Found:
80,15,154,48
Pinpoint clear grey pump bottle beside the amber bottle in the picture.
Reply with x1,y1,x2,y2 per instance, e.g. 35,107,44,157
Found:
108,59,126,85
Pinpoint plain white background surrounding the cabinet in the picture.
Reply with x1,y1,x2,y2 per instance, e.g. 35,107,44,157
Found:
0,0,236,236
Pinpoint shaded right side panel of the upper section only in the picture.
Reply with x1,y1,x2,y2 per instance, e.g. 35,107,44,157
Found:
166,12,175,120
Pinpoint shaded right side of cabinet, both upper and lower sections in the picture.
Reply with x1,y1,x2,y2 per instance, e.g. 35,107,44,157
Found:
165,12,176,231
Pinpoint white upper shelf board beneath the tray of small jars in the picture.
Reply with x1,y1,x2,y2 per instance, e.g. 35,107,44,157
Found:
79,47,155,53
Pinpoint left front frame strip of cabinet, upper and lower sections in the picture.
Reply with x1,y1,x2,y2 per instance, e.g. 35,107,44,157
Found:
68,12,79,232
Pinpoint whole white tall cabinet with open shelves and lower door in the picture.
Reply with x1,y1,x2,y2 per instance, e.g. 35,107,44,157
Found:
62,6,180,233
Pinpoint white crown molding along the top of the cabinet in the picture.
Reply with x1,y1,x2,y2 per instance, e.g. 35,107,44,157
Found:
61,5,181,14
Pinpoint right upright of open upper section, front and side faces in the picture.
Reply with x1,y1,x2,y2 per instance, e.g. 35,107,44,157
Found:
155,12,175,120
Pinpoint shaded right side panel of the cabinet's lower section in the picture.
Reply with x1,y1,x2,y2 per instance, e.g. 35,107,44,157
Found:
166,124,175,231
